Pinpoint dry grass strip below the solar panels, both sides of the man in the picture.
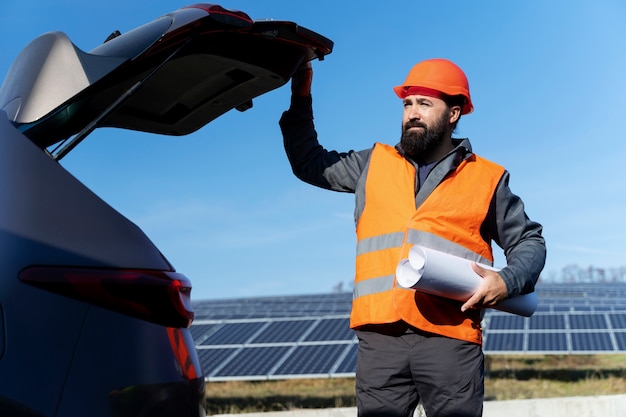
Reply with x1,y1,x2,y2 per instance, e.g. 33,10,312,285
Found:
206,355,626,414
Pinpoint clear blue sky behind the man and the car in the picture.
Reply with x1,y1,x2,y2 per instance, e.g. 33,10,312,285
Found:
0,0,626,299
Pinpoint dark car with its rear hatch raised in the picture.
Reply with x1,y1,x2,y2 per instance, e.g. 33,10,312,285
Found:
0,4,333,417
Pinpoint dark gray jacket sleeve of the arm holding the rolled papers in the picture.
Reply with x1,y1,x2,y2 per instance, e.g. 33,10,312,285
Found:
487,171,546,297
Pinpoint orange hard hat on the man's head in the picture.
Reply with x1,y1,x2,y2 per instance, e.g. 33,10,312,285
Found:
393,58,474,114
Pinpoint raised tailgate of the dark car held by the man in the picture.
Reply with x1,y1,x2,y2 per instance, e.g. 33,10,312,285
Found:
0,4,333,152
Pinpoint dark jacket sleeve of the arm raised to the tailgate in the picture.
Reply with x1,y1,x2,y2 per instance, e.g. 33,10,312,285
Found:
279,96,370,193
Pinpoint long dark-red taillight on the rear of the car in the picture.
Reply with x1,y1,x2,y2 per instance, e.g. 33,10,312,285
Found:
19,266,194,327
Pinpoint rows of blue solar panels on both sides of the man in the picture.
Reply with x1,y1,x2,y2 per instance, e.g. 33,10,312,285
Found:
190,283,626,381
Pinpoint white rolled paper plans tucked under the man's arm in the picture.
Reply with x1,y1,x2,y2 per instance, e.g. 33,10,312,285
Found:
396,245,537,317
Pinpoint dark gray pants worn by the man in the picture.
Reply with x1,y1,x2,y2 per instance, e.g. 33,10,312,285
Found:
356,325,484,417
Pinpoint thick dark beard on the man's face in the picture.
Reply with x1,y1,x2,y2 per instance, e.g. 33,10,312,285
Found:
400,113,449,162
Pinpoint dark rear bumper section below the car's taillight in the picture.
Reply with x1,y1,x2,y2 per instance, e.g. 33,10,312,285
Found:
57,307,205,417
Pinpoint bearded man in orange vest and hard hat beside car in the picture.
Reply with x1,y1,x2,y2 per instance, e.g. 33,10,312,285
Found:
280,59,546,417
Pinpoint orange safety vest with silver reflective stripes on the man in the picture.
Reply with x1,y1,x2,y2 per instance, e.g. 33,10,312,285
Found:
350,143,504,344
